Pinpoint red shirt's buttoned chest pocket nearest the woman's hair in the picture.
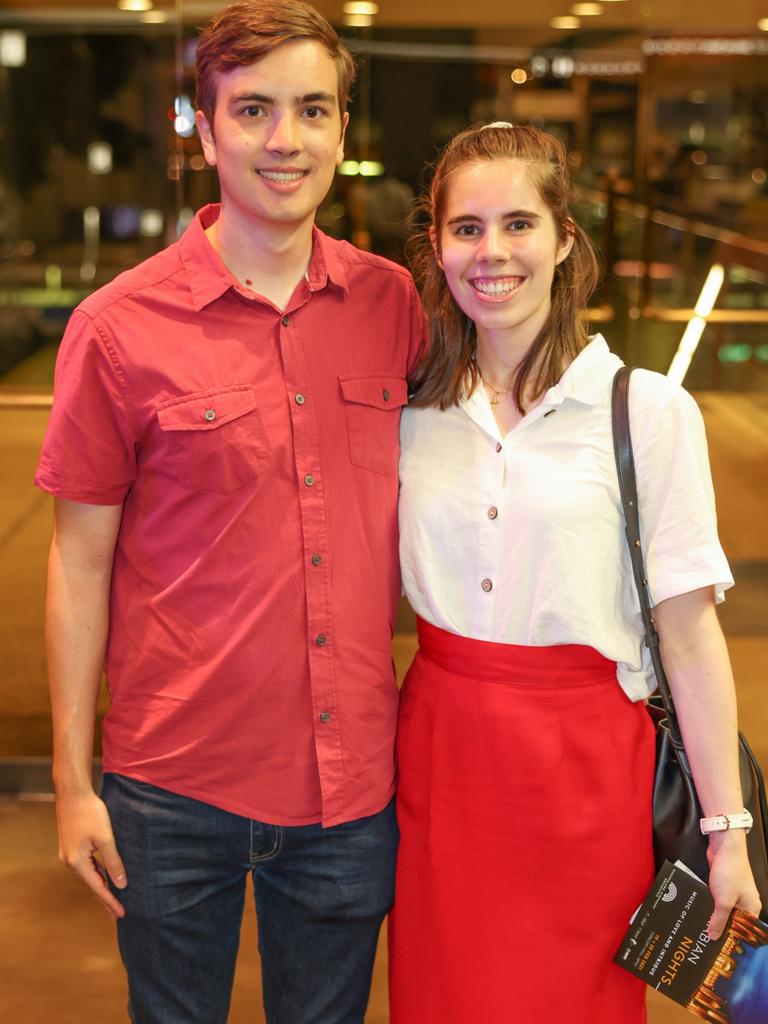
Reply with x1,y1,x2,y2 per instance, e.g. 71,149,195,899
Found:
339,375,408,473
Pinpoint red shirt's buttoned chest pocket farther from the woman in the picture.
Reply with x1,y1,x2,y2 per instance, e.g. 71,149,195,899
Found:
158,384,269,495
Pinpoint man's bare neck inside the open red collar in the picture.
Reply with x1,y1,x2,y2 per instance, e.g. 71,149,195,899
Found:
206,207,312,309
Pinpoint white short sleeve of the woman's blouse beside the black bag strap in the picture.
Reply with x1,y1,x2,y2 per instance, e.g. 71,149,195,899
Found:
630,371,733,604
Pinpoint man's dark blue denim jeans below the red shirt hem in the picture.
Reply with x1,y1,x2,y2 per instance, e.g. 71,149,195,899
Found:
102,774,397,1024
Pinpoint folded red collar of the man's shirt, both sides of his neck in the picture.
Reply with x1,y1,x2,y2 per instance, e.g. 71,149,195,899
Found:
178,203,349,312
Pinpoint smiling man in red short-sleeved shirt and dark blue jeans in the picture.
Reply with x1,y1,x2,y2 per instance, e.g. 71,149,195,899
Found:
37,0,422,1024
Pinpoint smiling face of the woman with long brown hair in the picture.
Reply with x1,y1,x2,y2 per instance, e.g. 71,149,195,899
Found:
438,159,572,346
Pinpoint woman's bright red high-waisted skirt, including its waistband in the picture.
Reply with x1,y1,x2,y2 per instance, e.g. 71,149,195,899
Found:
389,622,654,1024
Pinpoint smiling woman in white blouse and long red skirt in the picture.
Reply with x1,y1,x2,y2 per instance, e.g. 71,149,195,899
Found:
390,124,760,1024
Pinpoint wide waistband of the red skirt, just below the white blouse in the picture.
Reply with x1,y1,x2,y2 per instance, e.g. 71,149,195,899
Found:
417,616,616,687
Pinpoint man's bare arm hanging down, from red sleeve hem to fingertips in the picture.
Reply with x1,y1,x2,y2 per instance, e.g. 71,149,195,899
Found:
46,499,127,918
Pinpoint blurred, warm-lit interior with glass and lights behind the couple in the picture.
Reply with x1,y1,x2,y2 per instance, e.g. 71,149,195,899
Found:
0,0,768,1024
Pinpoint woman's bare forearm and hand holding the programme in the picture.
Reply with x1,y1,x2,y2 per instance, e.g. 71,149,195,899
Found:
653,587,760,939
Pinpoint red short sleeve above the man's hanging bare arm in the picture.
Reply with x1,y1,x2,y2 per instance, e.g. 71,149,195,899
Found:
35,310,137,505
